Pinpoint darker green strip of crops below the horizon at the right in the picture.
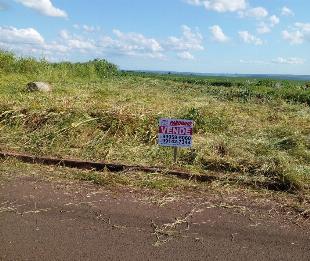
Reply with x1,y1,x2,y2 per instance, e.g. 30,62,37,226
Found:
122,72,310,105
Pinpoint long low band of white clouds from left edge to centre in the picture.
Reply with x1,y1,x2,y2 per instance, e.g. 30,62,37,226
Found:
0,27,165,61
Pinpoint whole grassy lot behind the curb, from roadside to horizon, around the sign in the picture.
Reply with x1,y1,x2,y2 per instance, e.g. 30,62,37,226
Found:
0,52,310,193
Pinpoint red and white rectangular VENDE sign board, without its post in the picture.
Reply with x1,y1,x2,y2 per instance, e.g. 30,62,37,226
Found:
158,119,194,147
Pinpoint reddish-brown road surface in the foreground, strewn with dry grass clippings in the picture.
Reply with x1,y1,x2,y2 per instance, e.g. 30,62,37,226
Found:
0,177,310,260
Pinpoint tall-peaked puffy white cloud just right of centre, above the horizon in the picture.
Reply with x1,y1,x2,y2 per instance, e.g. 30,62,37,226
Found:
166,25,204,51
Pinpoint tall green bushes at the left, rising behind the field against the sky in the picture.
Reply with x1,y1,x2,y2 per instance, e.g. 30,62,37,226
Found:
0,50,119,79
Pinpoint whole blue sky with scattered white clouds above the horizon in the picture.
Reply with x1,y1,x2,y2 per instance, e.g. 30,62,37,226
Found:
0,0,310,75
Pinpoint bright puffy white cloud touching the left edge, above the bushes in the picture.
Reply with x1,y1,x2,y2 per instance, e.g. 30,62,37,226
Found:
0,26,44,44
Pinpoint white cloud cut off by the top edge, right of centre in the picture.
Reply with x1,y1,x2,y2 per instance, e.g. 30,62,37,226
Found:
186,0,247,13
